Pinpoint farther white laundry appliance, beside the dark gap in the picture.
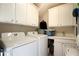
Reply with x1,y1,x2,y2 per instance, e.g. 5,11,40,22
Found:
27,31,48,56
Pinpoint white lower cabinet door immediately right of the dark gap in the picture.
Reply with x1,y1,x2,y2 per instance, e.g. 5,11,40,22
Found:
54,41,63,56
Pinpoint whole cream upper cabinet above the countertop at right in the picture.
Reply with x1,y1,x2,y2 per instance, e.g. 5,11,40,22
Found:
48,4,76,27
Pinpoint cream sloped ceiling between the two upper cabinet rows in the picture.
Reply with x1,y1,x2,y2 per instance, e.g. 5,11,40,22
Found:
34,3,63,17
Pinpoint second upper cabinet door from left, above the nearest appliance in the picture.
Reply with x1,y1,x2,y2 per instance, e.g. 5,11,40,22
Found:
16,3,27,25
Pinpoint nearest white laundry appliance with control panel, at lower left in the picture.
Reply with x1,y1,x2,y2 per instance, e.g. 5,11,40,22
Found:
2,32,38,56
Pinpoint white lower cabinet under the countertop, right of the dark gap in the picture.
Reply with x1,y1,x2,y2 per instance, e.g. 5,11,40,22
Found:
54,39,75,56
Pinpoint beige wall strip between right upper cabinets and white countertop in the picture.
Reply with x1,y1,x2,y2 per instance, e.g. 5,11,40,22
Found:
49,27,75,36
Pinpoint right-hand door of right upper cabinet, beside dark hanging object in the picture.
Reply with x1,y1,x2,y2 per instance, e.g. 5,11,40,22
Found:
62,4,76,26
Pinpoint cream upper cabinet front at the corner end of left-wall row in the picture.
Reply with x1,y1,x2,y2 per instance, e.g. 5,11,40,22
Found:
27,4,39,26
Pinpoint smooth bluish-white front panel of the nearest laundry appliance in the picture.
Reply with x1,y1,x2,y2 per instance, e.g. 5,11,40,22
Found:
13,41,37,56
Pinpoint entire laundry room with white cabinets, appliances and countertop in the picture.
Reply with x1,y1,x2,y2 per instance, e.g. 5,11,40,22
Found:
0,3,79,56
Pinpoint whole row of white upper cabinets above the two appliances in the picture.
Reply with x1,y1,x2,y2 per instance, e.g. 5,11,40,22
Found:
0,3,39,27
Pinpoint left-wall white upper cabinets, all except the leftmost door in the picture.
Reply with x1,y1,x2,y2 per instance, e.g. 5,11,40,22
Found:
16,3,38,26
